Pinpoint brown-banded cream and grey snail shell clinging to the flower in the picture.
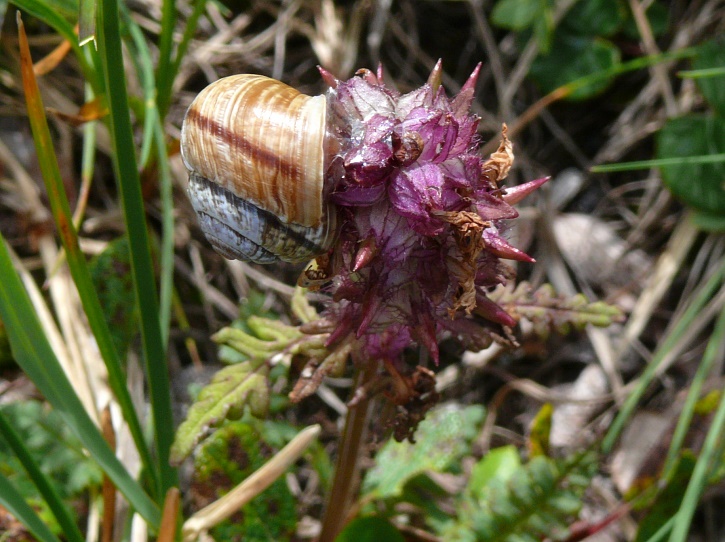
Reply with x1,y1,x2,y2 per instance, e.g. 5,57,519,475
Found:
181,75,337,263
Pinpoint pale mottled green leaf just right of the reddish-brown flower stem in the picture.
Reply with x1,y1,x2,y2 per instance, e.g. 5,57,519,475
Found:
363,405,484,498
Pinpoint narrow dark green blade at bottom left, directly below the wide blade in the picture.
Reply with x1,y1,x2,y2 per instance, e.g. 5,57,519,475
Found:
0,410,85,542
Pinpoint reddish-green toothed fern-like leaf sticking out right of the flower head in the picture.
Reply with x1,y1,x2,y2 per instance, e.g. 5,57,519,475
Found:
489,282,624,337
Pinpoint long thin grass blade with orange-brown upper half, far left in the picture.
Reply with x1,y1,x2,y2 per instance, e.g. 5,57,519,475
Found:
18,11,153,498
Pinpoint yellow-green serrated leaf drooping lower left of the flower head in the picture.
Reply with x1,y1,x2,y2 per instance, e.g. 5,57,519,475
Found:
171,362,269,465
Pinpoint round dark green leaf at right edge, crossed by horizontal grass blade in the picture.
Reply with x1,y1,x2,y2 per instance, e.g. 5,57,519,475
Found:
656,115,725,216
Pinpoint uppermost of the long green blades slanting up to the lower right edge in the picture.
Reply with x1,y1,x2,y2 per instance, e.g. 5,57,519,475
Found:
602,261,725,453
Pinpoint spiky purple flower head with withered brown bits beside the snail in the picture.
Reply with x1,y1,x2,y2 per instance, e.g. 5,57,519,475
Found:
300,62,545,404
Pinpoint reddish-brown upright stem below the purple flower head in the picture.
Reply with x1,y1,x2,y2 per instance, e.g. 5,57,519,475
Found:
319,362,378,542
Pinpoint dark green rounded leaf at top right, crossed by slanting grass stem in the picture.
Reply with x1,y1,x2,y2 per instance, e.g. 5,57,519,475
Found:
529,31,620,100
